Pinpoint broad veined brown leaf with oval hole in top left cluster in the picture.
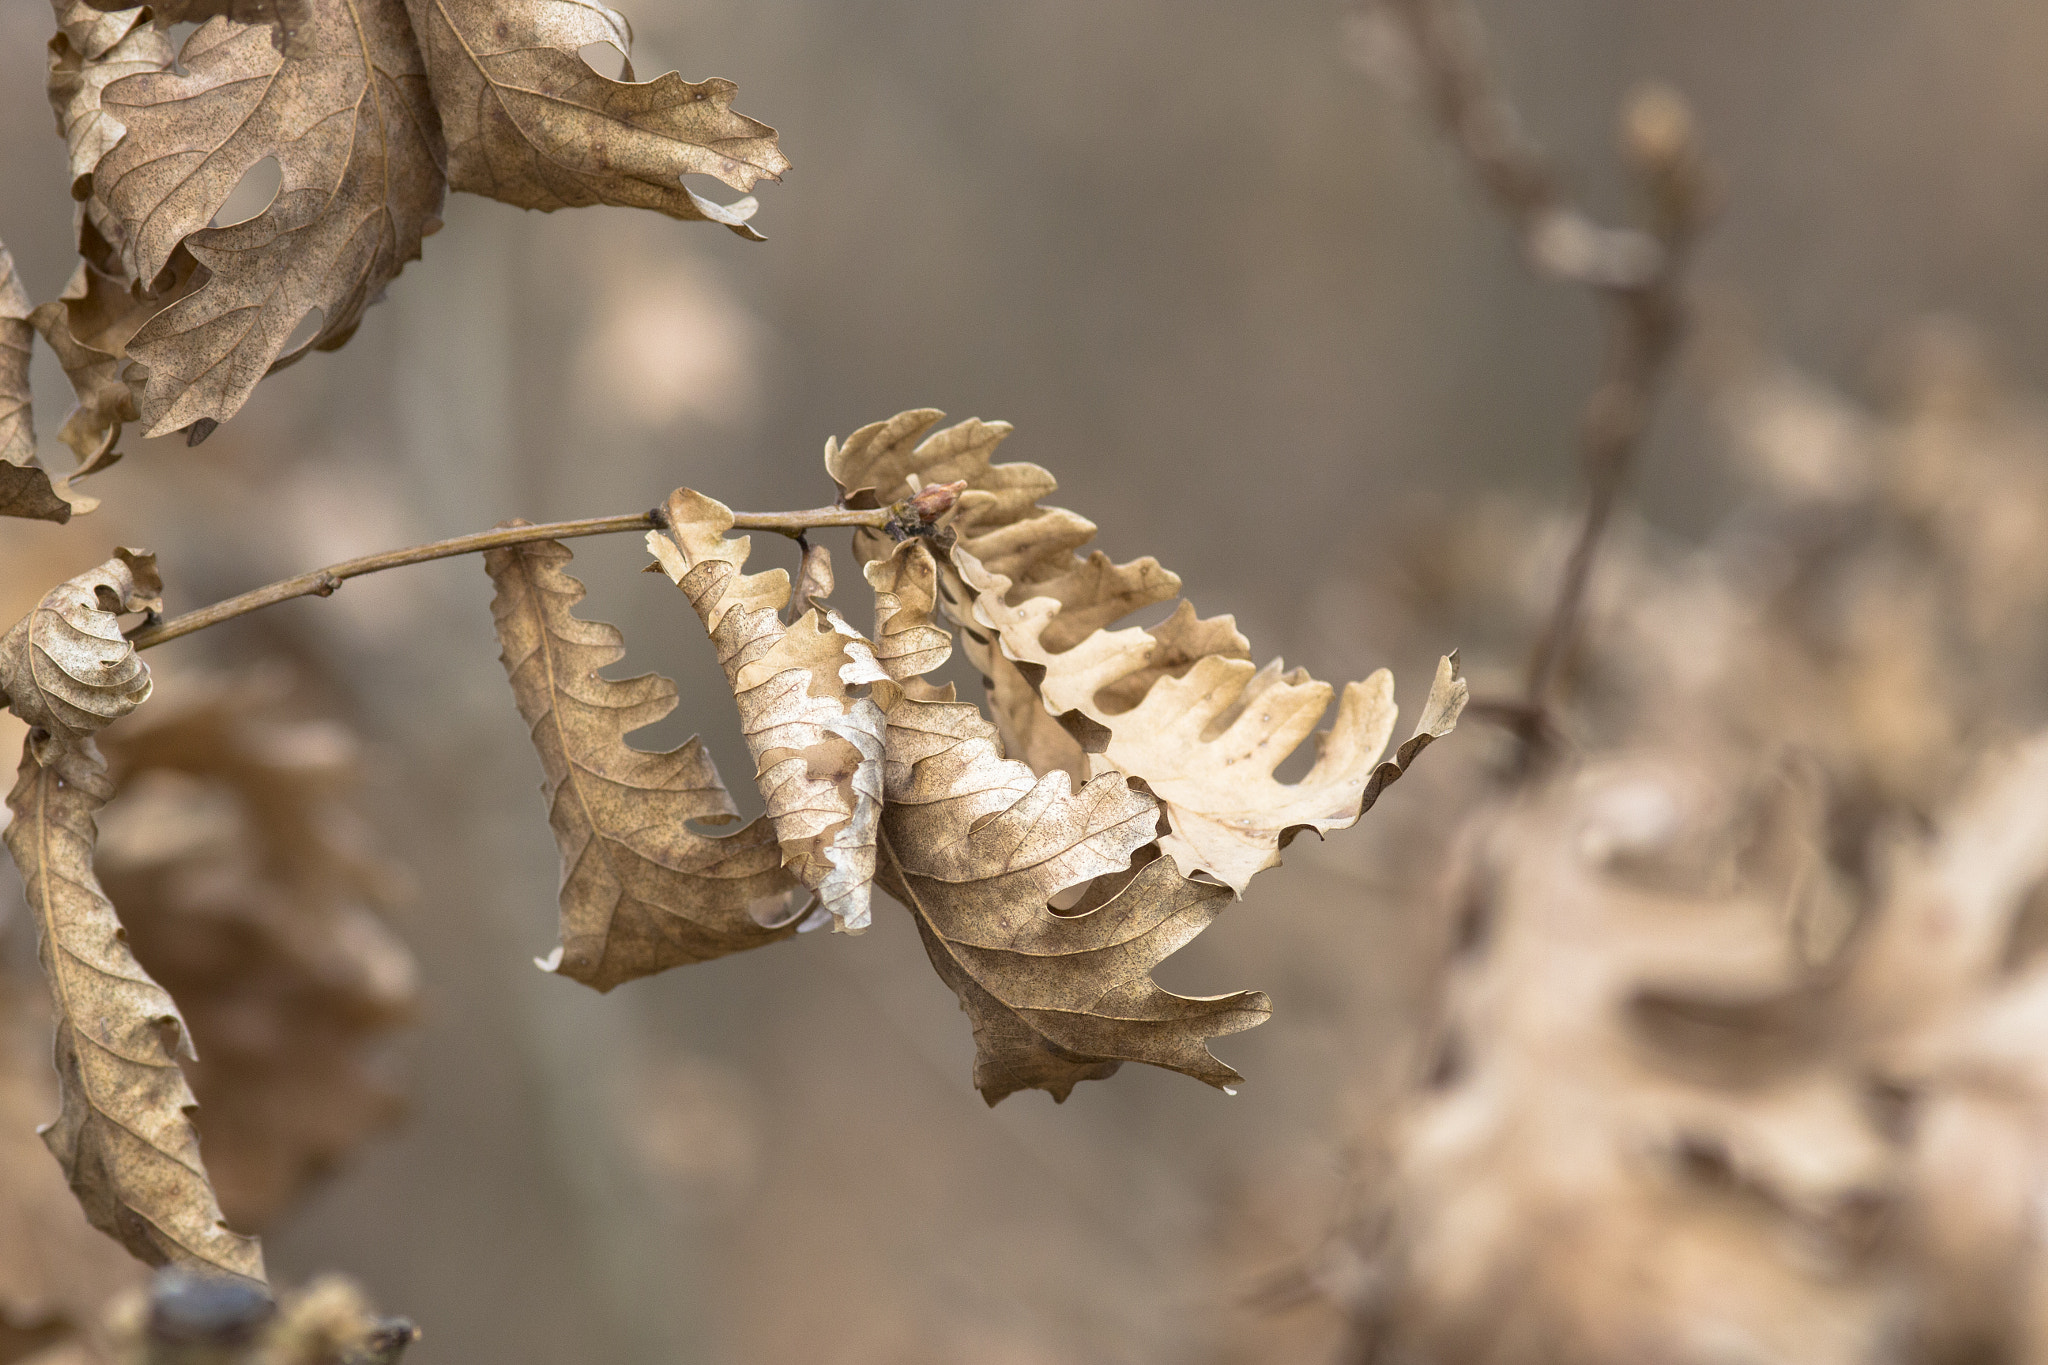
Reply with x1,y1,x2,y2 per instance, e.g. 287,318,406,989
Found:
94,0,444,436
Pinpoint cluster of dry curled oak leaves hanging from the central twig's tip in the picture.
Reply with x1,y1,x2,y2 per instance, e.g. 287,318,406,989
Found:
485,411,1464,1103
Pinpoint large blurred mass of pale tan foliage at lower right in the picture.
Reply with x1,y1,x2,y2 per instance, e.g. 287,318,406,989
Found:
1236,323,2048,1363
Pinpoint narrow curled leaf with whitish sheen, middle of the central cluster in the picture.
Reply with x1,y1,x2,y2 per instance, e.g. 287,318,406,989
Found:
647,489,889,933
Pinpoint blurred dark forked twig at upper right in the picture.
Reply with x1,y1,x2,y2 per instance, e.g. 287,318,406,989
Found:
1364,0,1710,757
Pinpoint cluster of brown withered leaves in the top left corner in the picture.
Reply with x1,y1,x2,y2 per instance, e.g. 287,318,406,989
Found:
0,0,788,522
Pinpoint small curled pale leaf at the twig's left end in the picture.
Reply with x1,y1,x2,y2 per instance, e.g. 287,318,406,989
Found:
0,548,164,757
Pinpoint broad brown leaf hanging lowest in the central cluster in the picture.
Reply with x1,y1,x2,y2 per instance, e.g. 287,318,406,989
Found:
868,540,1272,1105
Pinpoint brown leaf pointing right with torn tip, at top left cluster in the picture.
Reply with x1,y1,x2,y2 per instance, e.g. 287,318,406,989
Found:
406,0,788,239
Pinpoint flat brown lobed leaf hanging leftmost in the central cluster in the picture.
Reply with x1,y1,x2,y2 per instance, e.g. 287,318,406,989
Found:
483,540,795,990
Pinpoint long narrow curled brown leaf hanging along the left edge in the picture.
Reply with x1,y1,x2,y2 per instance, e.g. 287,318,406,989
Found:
6,737,262,1281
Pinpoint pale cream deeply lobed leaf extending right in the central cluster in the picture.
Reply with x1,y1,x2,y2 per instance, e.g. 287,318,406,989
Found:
825,409,1466,894
